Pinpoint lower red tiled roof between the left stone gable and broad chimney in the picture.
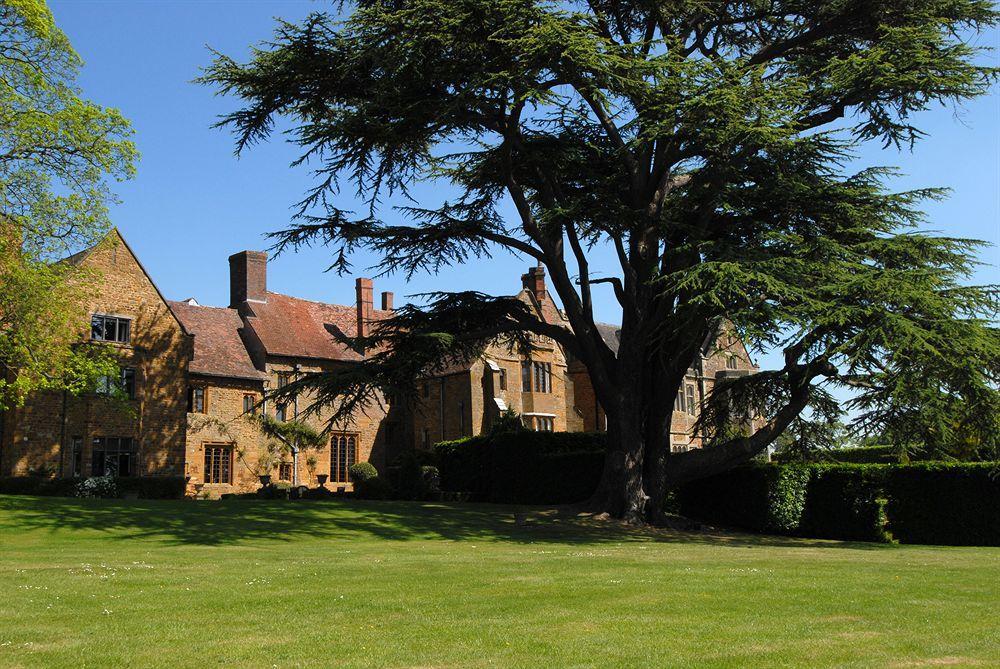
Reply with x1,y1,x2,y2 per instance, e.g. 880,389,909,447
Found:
167,300,266,380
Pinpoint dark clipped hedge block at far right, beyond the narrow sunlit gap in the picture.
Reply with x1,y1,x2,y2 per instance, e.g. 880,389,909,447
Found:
886,462,1000,546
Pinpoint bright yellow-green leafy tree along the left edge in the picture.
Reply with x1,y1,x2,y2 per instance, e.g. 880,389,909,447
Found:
0,0,136,409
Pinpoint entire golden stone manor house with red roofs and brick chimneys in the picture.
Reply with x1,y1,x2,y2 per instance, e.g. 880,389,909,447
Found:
0,231,755,496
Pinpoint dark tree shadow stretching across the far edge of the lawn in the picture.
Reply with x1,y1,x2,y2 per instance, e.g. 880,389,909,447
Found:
0,495,882,550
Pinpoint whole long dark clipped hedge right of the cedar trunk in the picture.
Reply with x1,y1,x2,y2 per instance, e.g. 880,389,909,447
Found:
676,462,1000,546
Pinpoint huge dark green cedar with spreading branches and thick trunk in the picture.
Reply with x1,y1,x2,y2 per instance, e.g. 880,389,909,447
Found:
203,0,1000,521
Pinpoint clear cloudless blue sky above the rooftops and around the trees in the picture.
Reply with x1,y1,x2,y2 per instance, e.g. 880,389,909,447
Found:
51,0,1000,366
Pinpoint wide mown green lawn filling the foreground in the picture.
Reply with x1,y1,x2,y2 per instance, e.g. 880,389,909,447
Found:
0,496,1000,667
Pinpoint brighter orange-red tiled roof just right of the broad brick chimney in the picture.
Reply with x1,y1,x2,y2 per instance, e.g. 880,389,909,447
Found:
247,292,392,360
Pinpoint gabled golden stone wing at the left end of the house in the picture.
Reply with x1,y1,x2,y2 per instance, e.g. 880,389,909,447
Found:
0,231,193,476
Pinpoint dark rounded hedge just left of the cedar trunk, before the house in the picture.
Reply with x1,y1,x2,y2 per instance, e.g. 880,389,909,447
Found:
435,431,607,504
